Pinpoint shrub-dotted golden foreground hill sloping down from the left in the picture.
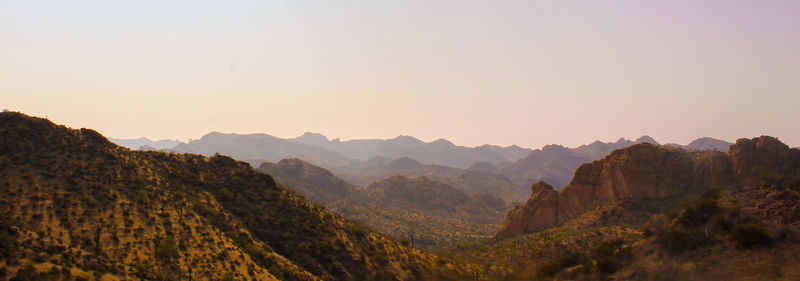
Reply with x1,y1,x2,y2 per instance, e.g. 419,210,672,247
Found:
0,112,463,280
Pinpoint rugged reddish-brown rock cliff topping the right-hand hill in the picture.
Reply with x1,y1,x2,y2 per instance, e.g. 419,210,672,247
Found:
495,136,800,239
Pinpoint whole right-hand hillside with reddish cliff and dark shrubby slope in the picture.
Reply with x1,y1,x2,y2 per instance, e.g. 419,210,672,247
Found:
455,136,800,280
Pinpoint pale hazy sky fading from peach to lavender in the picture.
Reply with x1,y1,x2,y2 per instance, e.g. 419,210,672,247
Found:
0,0,800,147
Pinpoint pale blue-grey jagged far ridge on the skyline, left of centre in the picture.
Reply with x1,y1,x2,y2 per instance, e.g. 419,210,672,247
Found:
172,132,530,169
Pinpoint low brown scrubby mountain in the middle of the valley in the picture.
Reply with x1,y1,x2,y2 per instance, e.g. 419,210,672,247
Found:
329,176,508,248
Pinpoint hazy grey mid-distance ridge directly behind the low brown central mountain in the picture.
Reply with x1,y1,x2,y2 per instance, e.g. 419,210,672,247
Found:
331,157,530,202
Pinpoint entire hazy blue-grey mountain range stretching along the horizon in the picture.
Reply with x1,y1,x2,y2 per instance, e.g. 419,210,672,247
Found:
117,132,730,196
